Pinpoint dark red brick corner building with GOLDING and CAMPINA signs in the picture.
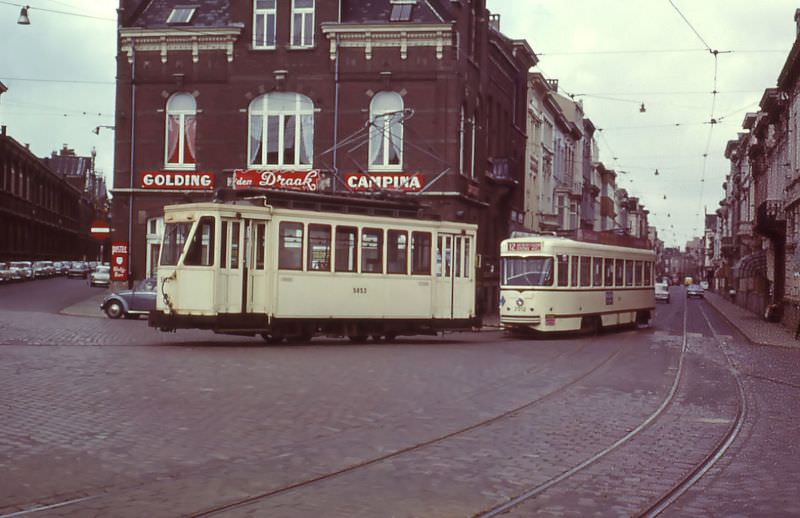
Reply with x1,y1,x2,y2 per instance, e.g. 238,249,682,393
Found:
112,0,537,308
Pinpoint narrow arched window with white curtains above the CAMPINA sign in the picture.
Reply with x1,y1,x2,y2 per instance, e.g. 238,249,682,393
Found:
369,92,403,171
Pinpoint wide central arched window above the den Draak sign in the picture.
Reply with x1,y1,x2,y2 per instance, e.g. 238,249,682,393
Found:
247,92,314,169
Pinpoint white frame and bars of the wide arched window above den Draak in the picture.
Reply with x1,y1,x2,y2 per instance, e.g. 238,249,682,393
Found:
247,92,314,171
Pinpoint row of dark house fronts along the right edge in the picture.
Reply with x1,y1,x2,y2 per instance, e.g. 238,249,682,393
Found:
704,9,800,327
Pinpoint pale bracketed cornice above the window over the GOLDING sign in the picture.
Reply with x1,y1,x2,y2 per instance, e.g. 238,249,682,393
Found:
119,27,242,63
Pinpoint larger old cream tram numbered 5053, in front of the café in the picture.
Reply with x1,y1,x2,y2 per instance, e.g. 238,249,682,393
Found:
149,198,479,342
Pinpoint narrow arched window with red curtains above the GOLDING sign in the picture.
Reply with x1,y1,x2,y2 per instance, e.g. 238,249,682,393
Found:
164,92,197,169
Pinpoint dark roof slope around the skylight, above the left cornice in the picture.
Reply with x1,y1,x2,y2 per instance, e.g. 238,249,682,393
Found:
127,0,231,29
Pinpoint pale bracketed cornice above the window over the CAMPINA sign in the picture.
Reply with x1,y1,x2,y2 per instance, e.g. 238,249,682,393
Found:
322,22,454,60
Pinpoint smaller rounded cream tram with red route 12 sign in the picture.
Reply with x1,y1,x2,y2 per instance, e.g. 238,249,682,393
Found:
500,235,655,332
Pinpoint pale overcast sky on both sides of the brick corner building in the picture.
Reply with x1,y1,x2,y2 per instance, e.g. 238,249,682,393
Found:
0,0,798,250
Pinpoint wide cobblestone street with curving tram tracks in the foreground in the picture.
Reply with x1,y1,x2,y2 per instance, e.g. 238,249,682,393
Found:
0,279,800,517
